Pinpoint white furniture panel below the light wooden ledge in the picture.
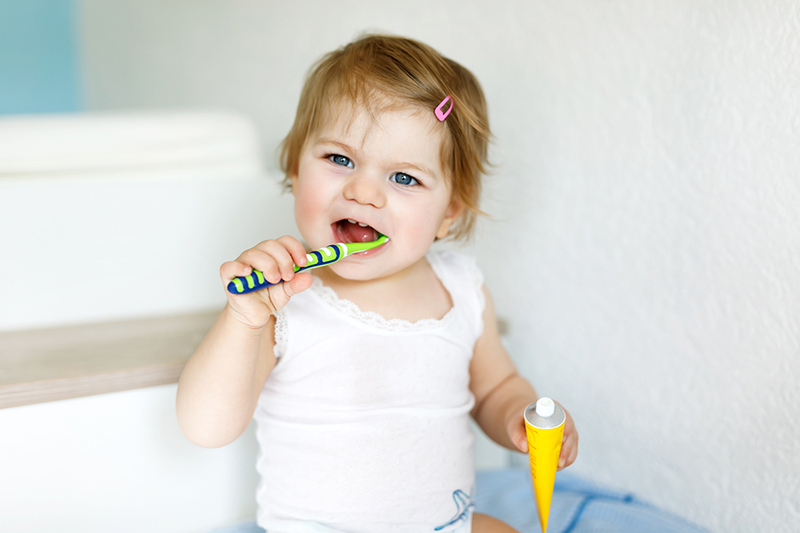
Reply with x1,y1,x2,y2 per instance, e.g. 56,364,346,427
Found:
0,385,258,533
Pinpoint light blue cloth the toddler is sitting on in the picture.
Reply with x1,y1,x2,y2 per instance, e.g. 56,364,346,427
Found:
208,469,707,533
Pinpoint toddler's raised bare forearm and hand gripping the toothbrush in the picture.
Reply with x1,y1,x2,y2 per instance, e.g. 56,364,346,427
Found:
175,236,311,448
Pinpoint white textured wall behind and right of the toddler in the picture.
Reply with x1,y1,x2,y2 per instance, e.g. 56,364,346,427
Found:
67,0,800,532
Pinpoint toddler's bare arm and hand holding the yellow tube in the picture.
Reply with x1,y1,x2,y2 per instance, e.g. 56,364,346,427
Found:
470,288,578,468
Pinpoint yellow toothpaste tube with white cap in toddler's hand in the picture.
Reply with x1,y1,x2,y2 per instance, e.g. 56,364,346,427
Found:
525,398,567,533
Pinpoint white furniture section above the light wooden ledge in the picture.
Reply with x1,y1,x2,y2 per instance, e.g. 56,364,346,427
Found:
0,111,294,331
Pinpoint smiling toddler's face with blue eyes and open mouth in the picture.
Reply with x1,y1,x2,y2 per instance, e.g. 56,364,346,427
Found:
292,101,461,280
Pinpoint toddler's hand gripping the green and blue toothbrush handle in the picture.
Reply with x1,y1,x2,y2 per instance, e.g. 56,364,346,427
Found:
219,235,318,329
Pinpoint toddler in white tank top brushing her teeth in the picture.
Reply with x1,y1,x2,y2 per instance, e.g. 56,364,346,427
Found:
177,35,578,533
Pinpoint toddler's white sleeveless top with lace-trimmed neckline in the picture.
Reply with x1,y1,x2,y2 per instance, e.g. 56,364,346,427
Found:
254,252,484,533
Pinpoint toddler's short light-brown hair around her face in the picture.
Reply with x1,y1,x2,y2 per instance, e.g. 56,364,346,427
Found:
280,35,490,239
